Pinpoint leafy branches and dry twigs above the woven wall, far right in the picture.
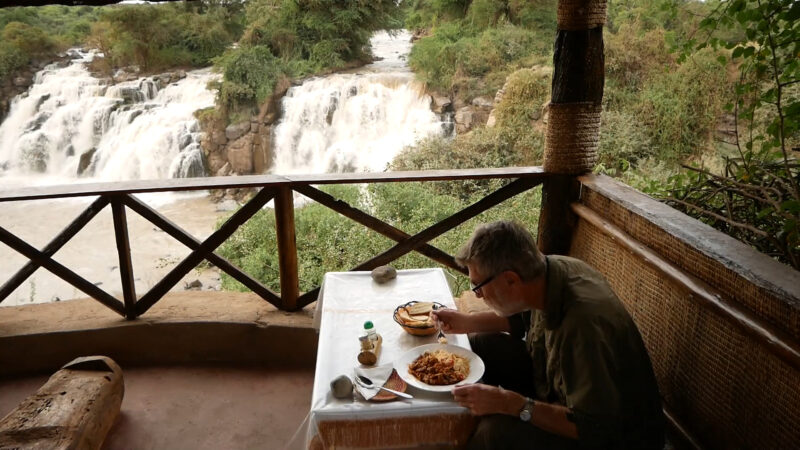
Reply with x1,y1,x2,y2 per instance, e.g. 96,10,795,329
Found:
668,0,800,269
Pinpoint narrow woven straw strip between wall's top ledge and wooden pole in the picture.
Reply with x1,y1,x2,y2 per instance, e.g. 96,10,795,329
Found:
581,186,800,340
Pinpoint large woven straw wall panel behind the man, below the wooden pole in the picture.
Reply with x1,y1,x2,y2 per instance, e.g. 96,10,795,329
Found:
570,220,800,448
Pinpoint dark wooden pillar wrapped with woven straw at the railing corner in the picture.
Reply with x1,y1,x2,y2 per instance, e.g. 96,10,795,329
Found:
539,0,606,254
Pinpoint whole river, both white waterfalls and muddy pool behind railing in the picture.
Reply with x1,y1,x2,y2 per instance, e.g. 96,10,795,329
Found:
0,32,452,306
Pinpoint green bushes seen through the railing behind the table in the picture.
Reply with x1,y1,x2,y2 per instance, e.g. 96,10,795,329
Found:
219,179,541,291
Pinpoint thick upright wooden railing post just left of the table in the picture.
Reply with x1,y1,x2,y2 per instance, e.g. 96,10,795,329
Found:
275,186,300,311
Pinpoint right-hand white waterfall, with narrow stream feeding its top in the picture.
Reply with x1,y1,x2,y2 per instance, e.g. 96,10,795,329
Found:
272,32,448,174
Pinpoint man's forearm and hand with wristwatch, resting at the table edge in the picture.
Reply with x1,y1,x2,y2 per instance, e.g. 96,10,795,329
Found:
453,384,578,439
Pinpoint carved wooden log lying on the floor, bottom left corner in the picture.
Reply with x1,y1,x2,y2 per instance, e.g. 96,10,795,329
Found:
0,356,125,450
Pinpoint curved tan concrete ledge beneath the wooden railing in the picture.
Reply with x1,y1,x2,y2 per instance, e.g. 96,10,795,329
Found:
0,291,317,376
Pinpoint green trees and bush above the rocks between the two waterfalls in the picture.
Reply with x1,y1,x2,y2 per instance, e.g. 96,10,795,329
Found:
216,0,401,111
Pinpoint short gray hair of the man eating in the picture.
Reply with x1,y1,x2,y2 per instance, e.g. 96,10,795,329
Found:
456,220,545,281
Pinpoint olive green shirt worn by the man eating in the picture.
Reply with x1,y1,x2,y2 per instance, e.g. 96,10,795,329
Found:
509,255,664,449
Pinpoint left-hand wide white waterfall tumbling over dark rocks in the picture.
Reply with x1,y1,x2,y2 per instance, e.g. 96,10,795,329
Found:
0,51,215,185
